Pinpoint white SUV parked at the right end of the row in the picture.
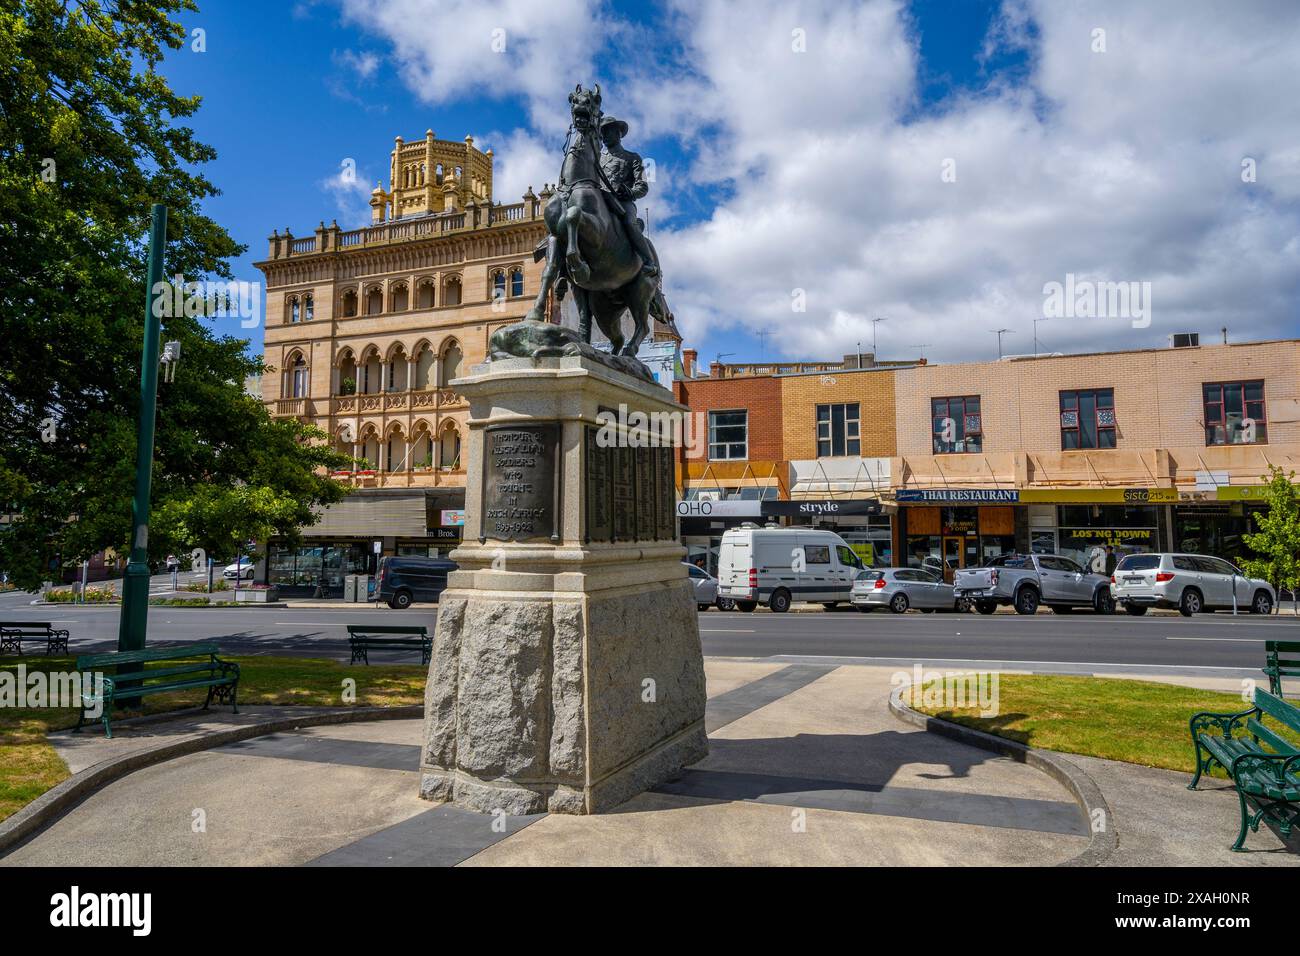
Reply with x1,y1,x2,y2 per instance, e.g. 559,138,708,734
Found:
1110,553,1278,618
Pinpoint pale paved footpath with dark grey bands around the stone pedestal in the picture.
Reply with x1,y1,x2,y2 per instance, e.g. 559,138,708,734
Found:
0,658,1300,866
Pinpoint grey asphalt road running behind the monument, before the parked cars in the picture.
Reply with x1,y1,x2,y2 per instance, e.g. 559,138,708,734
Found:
0,593,1300,671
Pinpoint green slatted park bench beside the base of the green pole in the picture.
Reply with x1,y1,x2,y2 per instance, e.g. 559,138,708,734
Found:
74,641,239,737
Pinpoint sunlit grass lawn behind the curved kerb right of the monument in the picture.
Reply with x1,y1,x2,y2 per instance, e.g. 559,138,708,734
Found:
905,674,1296,777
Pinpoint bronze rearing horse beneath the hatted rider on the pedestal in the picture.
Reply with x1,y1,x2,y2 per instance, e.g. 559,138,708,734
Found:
525,83,672,356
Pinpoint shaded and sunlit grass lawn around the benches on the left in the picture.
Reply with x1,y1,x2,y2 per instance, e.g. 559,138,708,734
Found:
0,657,428,819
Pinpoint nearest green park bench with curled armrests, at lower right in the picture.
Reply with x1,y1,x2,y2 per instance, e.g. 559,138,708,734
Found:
1187,687,1300,851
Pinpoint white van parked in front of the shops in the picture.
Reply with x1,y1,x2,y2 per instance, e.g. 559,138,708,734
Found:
718,528,862,613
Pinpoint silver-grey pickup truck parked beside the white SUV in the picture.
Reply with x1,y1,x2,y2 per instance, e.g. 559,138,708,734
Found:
953,554,1115,614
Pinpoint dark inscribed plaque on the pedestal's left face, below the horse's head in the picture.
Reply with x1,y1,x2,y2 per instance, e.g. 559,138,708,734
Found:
481,423,560,541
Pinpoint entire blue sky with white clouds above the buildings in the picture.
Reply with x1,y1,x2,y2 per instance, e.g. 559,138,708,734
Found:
165,0,1300,360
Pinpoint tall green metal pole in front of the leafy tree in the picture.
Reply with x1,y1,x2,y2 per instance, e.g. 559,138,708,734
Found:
117,203,166,674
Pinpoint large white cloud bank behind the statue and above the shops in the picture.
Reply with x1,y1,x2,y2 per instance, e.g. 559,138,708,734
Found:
327,0,1300,360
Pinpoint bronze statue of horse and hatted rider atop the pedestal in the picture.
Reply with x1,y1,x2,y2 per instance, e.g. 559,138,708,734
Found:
490,83,672,366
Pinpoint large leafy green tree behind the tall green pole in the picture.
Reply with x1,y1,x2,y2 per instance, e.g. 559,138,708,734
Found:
0,0,348,588
